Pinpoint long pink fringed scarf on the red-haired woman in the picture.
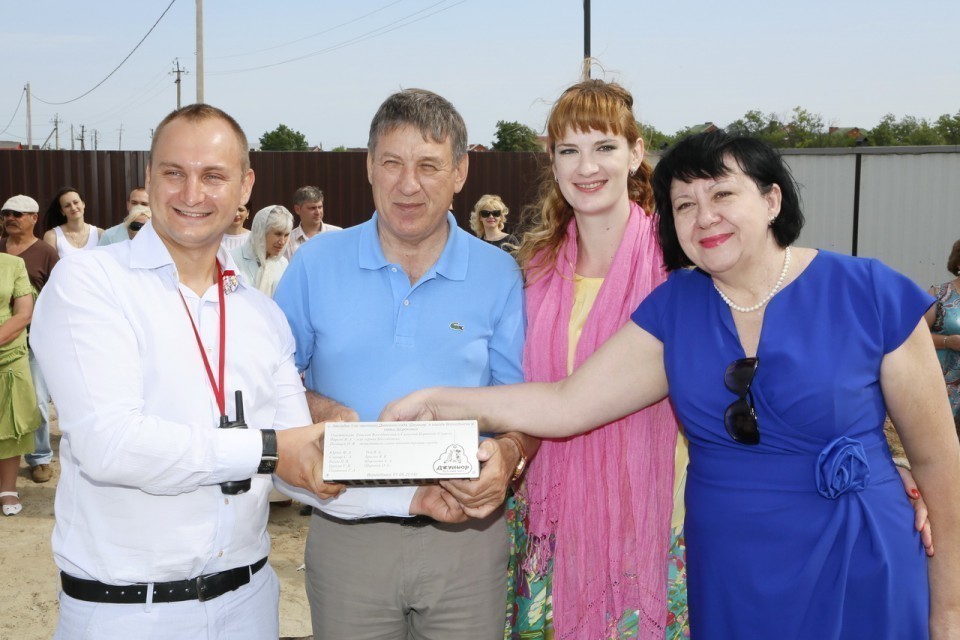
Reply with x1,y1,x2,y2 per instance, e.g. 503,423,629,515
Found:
523,203,677,640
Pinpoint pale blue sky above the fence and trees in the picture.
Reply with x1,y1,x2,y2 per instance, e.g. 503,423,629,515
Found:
0,0,960,149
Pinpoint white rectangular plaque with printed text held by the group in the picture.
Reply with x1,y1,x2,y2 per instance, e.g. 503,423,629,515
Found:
323,420,480,485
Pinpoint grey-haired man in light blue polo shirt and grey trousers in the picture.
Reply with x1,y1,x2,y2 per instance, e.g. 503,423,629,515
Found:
275,89,536,640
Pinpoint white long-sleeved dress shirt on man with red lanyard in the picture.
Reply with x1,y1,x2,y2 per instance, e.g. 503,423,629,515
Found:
31,223,310,584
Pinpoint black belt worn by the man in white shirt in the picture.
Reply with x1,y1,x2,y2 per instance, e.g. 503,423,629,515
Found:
60,558,267,604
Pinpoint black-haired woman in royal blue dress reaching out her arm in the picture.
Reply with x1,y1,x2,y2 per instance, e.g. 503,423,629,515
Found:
384,132,960,640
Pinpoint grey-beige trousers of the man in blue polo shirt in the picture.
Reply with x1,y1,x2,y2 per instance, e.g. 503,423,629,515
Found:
306,509,510,640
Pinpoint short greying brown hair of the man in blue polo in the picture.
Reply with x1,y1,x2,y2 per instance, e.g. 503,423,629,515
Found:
367,89,467,162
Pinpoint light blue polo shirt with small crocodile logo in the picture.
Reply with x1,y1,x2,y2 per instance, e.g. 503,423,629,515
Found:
274,213,524,516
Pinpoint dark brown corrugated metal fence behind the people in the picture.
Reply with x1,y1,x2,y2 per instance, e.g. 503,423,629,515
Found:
0,150,545,235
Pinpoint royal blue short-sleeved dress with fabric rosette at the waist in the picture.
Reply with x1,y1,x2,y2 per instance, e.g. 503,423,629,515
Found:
632,251,933,640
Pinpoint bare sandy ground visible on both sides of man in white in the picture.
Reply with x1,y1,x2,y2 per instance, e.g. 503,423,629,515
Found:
0,423,311,640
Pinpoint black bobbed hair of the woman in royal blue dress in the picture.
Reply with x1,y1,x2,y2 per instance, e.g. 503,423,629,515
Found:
653,130,803,271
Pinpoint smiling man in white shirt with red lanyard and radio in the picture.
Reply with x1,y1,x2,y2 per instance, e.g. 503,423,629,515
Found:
31,104,340,640
